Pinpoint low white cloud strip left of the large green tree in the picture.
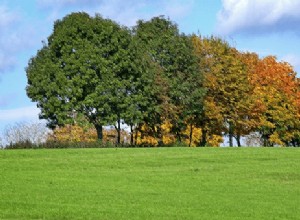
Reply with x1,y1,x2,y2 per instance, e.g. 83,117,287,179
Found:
0,106,40,123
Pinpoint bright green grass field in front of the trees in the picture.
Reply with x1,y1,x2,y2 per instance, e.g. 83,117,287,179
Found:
0,148,300,219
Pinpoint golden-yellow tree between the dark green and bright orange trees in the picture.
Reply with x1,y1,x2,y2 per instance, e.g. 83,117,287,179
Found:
193,36,251,146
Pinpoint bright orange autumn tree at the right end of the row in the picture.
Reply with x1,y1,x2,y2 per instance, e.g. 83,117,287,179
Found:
251,56,300,146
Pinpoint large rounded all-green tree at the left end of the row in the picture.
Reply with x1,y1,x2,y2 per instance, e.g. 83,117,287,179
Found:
26,13,137,139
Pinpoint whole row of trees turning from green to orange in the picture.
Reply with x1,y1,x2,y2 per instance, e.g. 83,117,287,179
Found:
26,13,300,146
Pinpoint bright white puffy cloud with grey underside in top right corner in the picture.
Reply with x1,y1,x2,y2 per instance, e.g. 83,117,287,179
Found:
217,0,300,35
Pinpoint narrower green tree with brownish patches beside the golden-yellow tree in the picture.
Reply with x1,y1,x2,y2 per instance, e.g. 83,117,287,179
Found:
134,17,204,144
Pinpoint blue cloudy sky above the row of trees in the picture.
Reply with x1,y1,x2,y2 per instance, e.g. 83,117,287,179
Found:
0,0,300,136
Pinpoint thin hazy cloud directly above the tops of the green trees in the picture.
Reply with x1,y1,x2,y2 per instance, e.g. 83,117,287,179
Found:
38,0,195,26
